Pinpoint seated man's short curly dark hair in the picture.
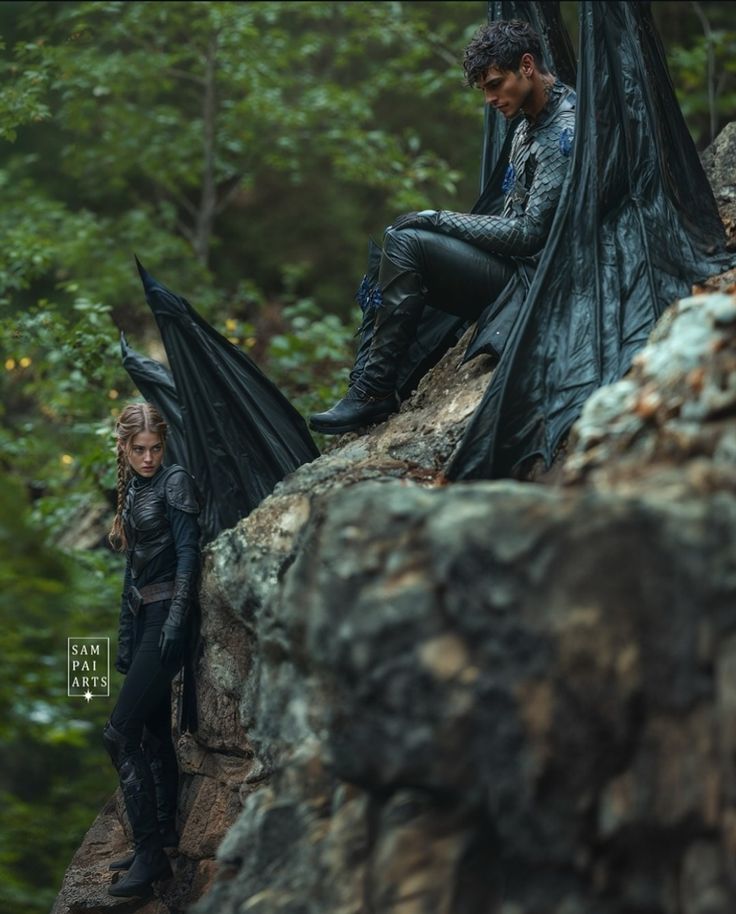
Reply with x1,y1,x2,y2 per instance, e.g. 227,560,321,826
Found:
463,19,549,86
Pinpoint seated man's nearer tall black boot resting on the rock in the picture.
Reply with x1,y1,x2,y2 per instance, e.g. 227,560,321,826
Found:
309,252,427,435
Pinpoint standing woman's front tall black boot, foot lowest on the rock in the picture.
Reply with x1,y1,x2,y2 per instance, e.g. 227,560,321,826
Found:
103,723,172,898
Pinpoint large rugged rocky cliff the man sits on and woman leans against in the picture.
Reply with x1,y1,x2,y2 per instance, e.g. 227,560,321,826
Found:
54,130,736,914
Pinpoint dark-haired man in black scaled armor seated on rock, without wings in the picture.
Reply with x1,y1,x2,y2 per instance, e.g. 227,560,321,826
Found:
310,20,575,435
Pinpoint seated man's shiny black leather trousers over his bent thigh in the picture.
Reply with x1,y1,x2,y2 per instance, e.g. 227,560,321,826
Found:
379,228,515,321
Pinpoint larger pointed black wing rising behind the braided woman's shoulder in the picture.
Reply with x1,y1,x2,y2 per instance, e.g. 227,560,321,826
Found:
136,259,319,542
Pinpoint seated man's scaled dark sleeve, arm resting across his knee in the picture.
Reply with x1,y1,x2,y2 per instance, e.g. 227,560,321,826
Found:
435,118,571,257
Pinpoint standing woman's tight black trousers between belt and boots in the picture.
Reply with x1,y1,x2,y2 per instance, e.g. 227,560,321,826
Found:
110,600,178,762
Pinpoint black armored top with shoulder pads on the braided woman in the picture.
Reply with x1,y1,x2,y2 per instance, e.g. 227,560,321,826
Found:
123,465,200,588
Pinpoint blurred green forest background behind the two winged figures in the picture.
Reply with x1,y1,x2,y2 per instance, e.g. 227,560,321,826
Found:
0,0,736,914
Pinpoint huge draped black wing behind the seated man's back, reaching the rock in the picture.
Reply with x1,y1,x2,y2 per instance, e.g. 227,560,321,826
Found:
448,0,732,479
